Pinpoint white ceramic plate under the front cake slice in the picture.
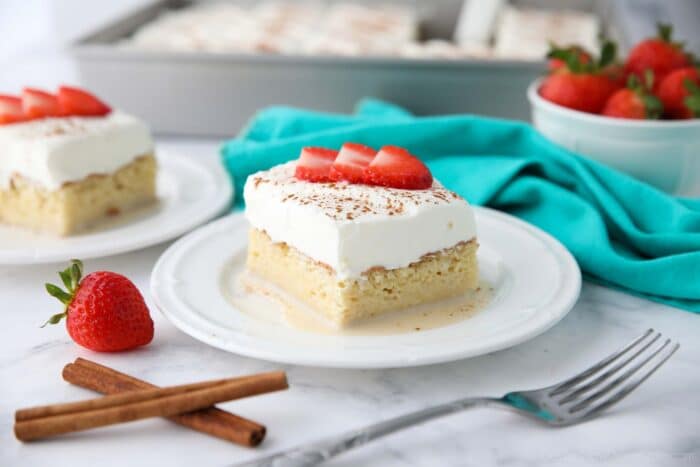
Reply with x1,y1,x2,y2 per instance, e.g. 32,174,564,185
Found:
151,208,581,368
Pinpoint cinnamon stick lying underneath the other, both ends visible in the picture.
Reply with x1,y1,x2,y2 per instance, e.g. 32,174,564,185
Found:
63,358,267,447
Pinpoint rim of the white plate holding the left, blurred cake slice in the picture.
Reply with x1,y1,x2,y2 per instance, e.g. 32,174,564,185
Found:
0,150,234,266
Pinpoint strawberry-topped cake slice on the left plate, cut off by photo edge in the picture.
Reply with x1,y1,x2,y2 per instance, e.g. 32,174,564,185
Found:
0,87,156,236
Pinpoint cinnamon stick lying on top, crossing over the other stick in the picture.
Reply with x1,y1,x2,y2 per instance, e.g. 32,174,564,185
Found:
15,371,288,441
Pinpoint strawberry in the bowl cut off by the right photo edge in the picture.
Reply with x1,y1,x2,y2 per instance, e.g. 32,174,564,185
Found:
658,67,700,119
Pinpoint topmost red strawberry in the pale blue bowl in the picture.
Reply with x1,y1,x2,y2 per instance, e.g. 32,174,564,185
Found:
625,24,692,85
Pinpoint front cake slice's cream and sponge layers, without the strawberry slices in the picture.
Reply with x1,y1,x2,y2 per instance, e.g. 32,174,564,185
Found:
244,144,478,326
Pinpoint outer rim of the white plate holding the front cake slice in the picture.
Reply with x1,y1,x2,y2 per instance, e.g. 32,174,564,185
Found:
150,206,582,369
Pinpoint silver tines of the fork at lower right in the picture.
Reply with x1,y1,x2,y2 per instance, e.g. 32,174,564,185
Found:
548,329,680,417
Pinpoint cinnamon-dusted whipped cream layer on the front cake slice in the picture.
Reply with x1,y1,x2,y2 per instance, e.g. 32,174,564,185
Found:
243,161,476,279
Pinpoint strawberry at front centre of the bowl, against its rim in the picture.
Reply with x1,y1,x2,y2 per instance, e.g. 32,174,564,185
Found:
602,70,664,120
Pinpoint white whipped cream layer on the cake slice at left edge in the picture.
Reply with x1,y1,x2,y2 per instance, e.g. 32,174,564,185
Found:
0,112,153,191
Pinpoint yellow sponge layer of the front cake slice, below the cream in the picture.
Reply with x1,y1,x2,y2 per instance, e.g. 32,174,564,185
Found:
247,228,479,327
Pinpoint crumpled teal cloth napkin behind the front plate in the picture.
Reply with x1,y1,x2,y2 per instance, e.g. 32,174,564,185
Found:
221,100,700,312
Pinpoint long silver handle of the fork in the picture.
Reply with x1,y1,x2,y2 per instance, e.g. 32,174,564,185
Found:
236,398,501,467
